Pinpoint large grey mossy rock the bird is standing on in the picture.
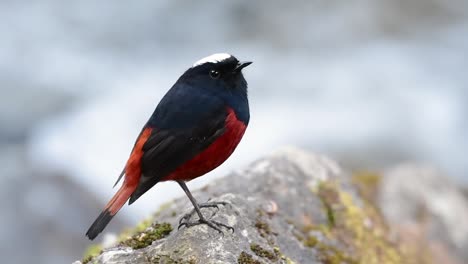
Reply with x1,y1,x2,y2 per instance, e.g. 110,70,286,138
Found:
75,149,452,264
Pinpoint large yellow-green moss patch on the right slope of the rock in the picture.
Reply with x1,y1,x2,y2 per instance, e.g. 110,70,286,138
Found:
315,183,404,264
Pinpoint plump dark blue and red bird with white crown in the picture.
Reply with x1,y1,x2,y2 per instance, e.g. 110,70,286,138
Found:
86,53,252,240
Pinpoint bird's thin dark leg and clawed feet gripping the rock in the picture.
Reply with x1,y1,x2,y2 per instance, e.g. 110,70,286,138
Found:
178,181,234,233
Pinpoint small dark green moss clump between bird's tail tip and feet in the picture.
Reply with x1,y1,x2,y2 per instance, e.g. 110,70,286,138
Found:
120,223,172,249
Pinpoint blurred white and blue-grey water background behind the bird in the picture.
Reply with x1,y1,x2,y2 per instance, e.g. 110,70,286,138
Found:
0,0,468,264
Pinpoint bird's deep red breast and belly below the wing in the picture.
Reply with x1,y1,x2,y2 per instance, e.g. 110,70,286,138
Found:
161,108,247,181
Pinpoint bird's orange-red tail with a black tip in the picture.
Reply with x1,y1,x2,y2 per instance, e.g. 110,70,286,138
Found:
86,183,137,240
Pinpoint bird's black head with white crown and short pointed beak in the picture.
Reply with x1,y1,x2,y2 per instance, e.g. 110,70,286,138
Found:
179,53,251,99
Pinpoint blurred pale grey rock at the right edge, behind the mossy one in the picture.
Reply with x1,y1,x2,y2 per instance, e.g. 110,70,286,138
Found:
379,164,468,263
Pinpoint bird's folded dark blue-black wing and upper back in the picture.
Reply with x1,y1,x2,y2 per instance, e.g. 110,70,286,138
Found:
129,83,227,204
